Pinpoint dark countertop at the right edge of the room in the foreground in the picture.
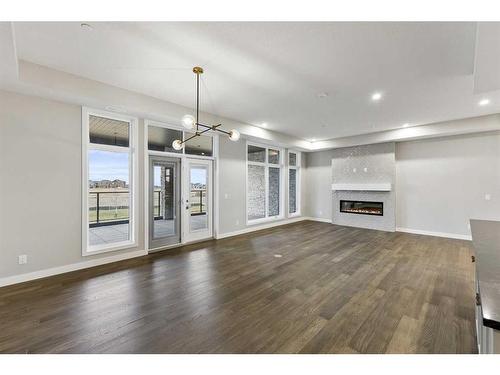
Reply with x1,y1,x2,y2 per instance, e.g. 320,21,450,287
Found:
470,220,500,329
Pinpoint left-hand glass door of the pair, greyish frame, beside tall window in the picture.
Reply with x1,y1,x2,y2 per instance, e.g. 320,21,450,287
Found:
148,156,182,249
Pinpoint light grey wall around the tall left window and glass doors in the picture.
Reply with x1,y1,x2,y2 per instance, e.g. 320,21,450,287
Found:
0,90,305,284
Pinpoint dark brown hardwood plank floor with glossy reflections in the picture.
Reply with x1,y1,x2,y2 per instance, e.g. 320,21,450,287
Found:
0,221,476,353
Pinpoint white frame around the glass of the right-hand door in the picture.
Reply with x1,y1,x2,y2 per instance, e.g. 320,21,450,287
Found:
181,157,215,243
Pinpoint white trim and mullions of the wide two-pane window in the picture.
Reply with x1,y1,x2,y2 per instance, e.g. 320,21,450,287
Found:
245,141,285,225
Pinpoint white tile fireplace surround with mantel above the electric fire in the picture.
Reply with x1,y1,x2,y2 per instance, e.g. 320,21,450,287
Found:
332,143,396,232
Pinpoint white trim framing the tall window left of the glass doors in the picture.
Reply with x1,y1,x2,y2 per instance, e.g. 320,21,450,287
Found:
82,107,139,257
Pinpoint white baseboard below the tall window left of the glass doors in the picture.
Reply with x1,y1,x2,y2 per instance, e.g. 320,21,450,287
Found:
0,250,148,287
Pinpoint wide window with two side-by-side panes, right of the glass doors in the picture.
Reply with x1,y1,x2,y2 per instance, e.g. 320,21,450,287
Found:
247,144,283,222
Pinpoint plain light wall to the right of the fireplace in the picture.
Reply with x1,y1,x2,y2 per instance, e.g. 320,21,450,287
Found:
396,132,500,236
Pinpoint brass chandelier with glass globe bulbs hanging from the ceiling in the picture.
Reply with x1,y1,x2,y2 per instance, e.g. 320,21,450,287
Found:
172,66,240,150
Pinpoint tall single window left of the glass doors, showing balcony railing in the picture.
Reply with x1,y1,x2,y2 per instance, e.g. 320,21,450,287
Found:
82,109,137,255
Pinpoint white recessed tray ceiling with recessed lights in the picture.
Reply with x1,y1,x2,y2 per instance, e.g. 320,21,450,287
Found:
8,22,500,140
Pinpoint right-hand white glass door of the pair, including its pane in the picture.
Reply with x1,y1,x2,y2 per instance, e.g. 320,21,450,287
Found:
182,158,213,242
